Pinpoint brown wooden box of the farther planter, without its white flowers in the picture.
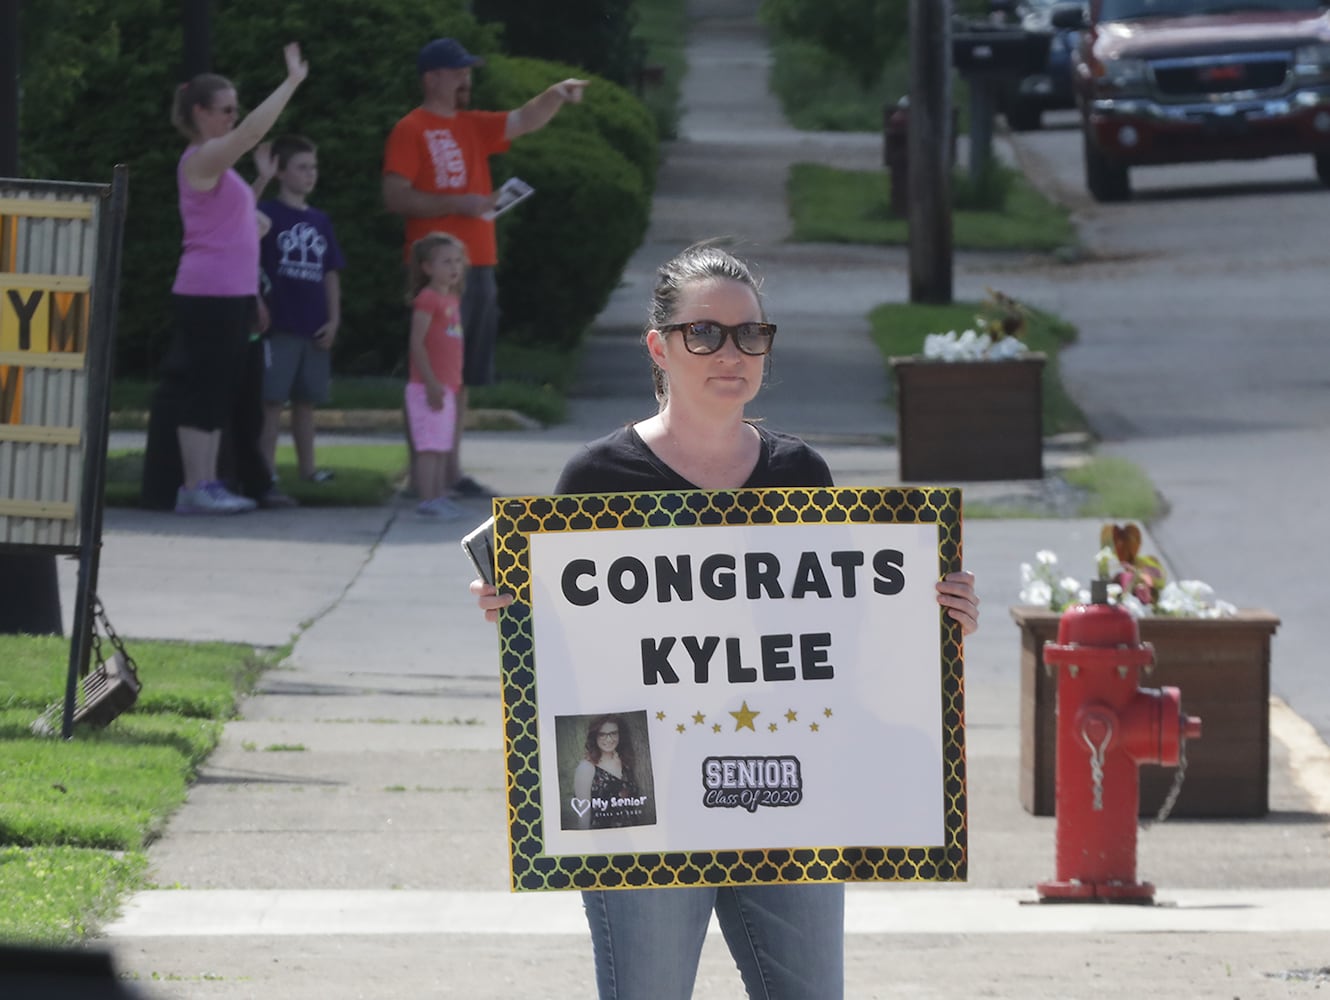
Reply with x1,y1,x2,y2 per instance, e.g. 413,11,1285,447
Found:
891,354,1044,481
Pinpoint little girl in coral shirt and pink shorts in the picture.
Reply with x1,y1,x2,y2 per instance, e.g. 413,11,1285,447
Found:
406,233,467,520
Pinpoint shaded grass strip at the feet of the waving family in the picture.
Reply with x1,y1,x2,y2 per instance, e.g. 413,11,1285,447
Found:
106,440,407,507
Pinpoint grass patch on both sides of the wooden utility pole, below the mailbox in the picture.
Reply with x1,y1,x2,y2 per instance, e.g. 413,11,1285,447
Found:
786,164,1076,253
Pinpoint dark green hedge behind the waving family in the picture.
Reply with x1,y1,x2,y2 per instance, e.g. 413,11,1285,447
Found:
21,0,656,375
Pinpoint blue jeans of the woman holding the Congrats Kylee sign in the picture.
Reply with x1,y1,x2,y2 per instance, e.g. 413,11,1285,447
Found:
583,883,845,1000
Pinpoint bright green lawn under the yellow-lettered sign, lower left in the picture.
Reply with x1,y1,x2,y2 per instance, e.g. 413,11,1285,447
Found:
0,636,269,945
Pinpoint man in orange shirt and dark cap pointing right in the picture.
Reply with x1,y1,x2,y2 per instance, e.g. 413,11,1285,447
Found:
383,39,587,496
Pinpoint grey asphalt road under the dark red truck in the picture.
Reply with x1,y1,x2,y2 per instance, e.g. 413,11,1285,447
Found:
1013,113,1330,738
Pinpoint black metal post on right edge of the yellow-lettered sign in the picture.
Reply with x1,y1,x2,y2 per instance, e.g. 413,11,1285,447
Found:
60,164,129,739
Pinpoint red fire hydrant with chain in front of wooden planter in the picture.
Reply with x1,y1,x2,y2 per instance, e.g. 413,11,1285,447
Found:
1037,580,1201,904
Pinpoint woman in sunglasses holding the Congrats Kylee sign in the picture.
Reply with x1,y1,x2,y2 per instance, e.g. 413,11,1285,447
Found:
471,243,979,1000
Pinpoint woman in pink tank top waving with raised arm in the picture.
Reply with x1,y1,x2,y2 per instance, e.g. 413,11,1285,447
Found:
164,43,309,513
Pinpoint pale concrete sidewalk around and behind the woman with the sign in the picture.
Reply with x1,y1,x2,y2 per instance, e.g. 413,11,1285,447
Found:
85,0,1330,1000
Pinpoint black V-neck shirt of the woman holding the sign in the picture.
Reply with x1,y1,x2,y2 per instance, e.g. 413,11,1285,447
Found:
555,424,831,493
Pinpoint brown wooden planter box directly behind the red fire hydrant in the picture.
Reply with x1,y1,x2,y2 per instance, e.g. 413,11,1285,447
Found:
1011,608,1279,818
